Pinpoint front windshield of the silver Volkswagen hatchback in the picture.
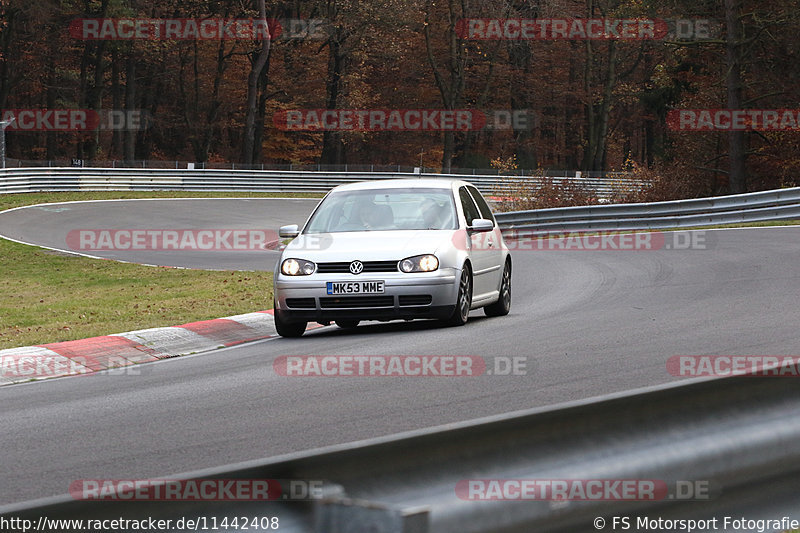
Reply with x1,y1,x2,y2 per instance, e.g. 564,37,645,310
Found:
304,188,456,233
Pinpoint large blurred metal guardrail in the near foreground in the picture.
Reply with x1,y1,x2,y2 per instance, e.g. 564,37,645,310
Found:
0,366,800,533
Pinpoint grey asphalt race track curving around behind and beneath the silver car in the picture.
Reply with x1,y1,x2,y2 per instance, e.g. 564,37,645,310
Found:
0,200,800,505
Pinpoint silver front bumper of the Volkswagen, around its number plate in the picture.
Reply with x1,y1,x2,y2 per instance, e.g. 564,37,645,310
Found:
275,268,460,323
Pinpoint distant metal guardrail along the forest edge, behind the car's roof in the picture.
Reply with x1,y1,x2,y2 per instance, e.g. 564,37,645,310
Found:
0,167,640,197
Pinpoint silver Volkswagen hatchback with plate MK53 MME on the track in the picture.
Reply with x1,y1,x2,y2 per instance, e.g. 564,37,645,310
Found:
275,179,511,337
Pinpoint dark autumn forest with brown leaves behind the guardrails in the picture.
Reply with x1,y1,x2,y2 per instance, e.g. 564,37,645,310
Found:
0,0,800,195
